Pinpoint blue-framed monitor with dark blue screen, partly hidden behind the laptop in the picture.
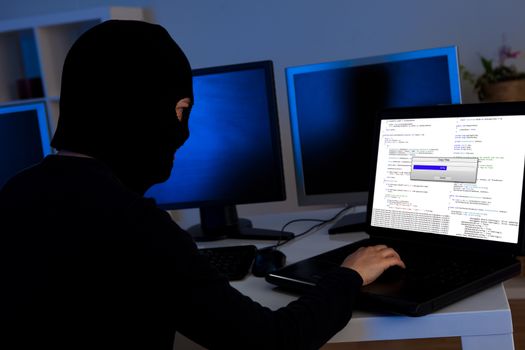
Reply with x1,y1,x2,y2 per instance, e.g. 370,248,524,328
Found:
287,49,460,200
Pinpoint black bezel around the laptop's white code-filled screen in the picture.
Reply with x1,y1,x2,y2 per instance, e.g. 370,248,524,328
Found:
366,102,525,255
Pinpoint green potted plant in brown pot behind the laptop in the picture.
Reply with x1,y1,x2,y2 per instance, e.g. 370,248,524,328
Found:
460,45,525,101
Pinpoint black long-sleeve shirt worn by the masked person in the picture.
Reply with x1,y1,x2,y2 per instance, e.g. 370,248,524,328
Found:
0,156,362,349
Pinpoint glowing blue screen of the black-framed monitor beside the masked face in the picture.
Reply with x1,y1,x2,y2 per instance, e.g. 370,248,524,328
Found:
146,64,284,208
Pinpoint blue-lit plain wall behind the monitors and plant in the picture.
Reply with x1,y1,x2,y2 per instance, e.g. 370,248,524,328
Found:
0,0,525,220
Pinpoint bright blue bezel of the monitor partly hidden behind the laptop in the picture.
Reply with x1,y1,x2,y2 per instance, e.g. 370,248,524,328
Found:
285,46,461,206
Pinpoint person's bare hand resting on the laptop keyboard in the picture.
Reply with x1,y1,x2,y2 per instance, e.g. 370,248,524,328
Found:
341,245,405,286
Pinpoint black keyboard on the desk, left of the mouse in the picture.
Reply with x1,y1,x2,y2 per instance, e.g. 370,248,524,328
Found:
199,245,257,281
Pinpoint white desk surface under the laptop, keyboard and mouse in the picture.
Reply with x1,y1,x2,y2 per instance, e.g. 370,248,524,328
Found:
174,206,514,350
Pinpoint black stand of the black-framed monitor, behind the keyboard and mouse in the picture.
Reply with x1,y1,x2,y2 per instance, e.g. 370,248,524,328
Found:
188,205,294,242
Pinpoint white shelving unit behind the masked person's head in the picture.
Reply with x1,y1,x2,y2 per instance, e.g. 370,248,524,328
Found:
0,7,144,134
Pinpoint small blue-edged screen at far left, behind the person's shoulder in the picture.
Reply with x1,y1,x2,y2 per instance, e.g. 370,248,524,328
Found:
0,103,51,188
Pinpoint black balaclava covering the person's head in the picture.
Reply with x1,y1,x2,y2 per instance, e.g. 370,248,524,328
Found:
51,20,193,194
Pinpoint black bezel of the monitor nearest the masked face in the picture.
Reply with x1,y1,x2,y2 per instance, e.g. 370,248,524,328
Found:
151,60,286,210
